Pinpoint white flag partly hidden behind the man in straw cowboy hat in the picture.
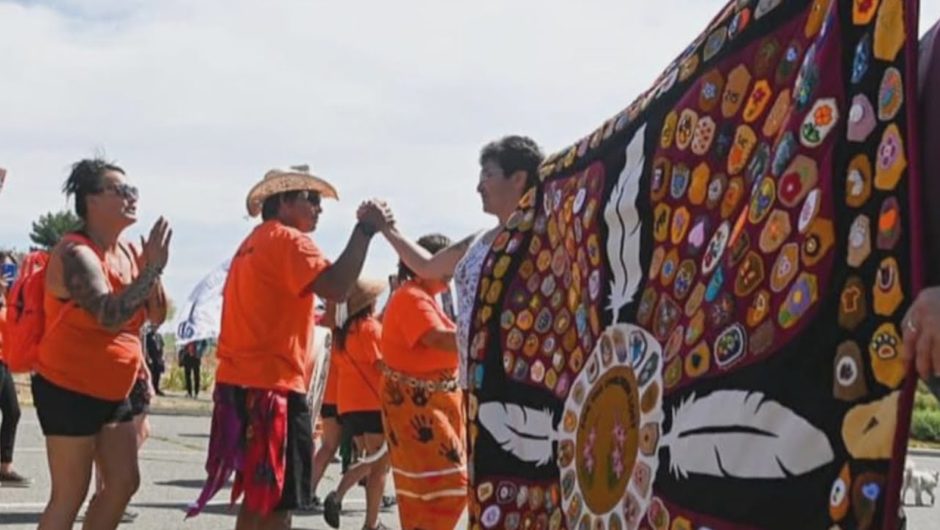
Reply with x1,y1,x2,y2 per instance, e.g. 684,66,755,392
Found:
176,260,232,346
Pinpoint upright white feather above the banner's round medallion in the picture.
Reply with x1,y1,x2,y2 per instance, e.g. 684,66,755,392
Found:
604,124,646,320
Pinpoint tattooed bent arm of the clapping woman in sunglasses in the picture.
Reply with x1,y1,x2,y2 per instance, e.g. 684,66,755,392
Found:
62,246,160,330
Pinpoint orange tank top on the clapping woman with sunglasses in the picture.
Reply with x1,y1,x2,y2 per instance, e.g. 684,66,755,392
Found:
36,237,147,401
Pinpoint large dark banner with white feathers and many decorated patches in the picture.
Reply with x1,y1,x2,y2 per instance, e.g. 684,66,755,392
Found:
468,0,920,530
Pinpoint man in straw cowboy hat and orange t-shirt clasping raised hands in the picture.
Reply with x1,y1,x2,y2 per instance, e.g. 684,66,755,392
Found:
190,167,392,529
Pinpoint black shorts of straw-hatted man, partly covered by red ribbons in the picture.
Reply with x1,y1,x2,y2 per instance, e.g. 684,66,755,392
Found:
236,388,313,511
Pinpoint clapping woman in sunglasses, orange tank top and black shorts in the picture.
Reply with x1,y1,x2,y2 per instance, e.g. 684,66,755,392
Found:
32,159,172,529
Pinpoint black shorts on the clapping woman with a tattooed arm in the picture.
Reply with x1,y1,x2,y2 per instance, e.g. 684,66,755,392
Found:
32,374,134,436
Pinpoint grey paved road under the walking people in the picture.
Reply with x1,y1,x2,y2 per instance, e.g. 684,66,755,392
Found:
0,409,940,530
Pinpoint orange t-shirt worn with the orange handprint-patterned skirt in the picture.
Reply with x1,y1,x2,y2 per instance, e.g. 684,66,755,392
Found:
382,282,457,375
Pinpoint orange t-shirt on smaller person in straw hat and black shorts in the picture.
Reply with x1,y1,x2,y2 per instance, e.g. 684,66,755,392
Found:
336,317,382,414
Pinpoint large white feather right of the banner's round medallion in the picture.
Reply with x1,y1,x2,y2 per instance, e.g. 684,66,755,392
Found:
662,390,833,479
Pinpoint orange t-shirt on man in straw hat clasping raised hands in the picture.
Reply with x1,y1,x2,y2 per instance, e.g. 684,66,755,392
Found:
216,221,330,394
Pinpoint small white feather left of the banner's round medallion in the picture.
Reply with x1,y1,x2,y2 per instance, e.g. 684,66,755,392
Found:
478,401,555,466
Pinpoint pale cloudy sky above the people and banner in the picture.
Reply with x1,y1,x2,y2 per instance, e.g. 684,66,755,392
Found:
0,0,940,318
